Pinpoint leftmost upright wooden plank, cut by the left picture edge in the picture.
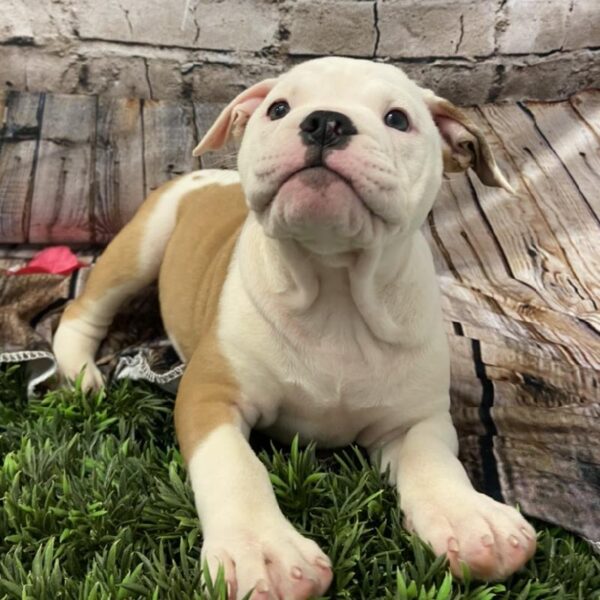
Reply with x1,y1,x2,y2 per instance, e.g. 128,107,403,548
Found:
0,92,43,244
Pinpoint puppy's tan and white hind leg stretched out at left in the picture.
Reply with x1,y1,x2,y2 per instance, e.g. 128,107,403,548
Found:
53,175,188,389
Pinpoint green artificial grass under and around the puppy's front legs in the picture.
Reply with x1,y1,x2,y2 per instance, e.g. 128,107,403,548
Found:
0,367,600,600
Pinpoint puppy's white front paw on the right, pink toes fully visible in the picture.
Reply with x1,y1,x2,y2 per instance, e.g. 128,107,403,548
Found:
403,491,536,581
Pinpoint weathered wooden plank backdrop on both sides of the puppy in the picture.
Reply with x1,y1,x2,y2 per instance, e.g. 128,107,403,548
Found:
0,91,600,535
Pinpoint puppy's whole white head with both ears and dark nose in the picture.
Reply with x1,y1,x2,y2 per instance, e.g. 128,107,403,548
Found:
194,58,510,254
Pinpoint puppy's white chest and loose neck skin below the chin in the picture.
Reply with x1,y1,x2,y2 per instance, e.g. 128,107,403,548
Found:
219,218,449,446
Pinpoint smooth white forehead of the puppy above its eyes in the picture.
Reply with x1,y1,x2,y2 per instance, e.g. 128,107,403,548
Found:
269,57,424,109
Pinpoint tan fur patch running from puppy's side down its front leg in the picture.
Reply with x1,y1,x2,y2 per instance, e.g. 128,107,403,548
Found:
159,184,248,461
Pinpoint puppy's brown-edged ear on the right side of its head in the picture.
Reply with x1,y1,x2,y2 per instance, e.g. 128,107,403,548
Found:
423,90,515,194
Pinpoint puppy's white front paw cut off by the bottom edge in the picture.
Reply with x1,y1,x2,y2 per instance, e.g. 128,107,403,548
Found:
202,521,332,600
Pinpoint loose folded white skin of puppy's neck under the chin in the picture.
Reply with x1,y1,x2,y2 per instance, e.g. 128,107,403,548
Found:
238,220,413,344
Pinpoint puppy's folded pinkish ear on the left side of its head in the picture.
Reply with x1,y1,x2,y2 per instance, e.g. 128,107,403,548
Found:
193,79,277,156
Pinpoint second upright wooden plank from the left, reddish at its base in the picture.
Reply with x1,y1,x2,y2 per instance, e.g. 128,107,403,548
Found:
29,94,97,243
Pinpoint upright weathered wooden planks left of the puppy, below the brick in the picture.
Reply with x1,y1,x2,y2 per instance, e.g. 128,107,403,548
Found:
0,92,216,246
